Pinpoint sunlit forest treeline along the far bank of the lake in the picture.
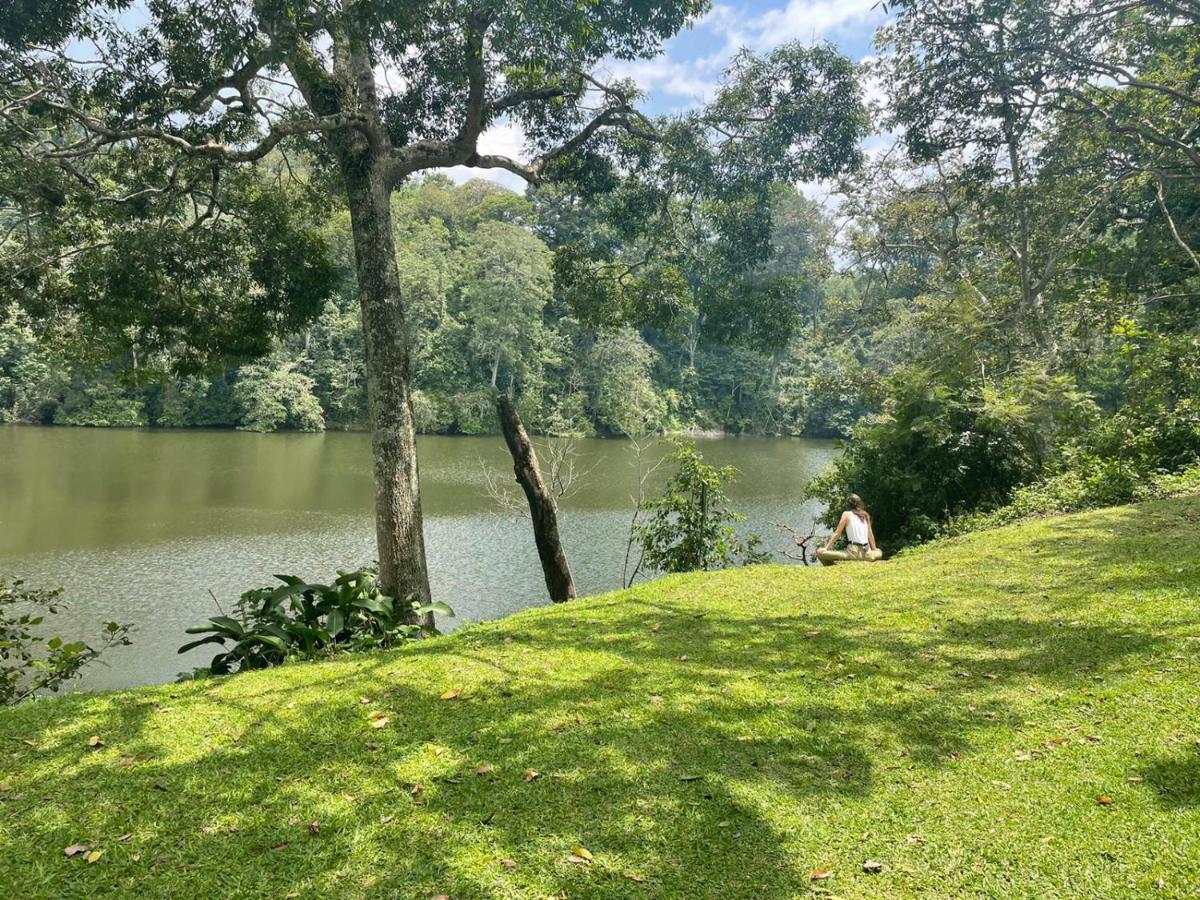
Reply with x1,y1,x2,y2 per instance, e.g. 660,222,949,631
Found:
0,176,863,436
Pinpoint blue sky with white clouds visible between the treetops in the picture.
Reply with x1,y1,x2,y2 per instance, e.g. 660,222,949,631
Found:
448,0,887,191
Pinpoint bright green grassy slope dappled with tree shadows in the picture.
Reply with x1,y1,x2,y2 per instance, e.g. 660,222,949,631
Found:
0,499,1200,900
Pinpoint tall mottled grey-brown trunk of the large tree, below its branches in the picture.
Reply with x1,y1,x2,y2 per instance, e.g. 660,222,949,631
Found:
342,160,433,628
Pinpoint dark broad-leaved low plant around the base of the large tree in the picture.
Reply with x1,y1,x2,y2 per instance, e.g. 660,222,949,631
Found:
179,569,454,676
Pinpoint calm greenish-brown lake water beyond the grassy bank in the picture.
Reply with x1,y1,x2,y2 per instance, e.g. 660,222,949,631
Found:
0,426,836,689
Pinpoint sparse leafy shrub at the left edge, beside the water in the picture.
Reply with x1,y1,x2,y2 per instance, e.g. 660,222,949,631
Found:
0,578,132,706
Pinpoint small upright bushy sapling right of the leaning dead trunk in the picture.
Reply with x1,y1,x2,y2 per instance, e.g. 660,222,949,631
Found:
630,440,769,583
